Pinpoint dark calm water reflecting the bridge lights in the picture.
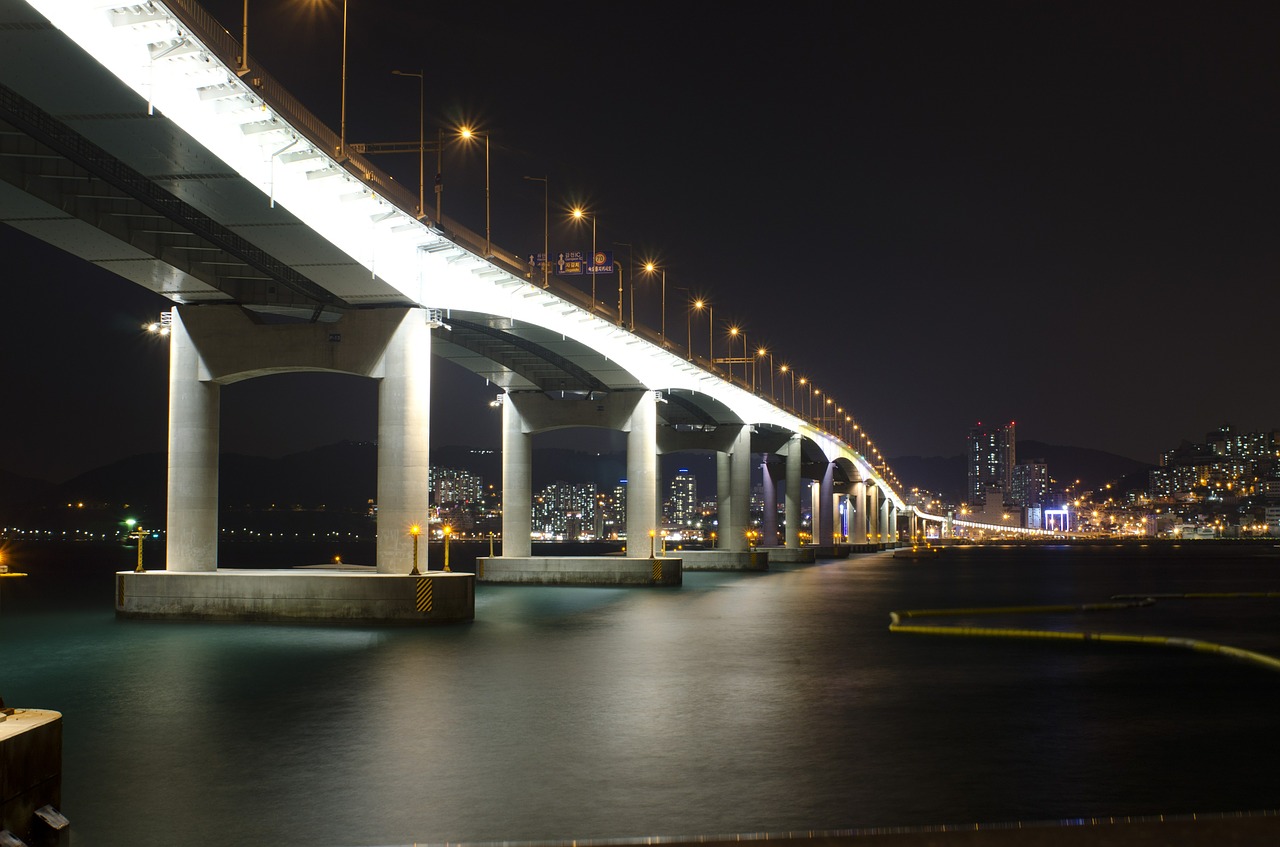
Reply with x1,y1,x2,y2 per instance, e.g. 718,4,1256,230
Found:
0,545,1280,847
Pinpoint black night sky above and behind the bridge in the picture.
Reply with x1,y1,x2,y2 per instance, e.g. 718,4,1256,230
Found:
0,0,1280,482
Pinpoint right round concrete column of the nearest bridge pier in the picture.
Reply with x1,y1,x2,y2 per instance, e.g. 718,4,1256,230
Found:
378,308,431,573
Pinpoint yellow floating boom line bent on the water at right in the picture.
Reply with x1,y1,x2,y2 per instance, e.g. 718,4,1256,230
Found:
888,592,1280,670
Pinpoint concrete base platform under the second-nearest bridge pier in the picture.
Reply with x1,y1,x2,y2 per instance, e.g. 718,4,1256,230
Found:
476,555,684,586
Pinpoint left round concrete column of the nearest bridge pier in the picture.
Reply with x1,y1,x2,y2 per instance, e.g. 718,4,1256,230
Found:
165,307,220,571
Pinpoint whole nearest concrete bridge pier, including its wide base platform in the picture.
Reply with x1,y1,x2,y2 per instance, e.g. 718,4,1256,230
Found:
115,306,475,624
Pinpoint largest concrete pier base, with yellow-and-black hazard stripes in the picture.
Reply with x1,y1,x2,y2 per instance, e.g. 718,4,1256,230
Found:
115,567,476,626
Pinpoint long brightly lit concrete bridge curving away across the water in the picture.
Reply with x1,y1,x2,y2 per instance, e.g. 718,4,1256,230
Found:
0,0,977,617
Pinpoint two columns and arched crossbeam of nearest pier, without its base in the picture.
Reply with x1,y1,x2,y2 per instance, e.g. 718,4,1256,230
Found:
165,306,431,573
